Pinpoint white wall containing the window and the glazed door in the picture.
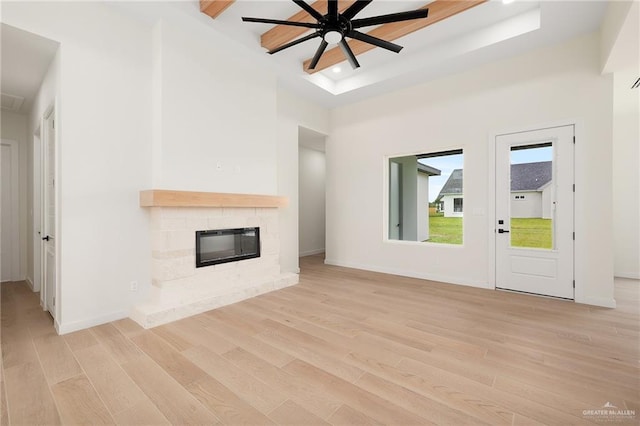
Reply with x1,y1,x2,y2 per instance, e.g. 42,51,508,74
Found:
327,35,615,306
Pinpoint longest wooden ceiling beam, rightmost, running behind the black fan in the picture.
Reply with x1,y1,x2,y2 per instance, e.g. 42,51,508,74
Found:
302,0,487,74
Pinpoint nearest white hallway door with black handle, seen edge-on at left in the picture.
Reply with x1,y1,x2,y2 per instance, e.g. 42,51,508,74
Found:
42,113,56,318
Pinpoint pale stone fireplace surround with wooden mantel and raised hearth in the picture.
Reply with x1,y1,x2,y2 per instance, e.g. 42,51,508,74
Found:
131,190,298,328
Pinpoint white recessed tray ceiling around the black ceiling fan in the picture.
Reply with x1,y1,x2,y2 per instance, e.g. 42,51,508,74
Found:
202,0,607,107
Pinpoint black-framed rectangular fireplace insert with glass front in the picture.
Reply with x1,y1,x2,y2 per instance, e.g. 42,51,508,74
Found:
196,227,260,268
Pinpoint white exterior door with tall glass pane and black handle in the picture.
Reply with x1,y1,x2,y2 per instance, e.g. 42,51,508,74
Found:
496,126,574,299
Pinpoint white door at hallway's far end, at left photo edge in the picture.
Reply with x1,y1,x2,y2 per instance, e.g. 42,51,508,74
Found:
0,140,20,281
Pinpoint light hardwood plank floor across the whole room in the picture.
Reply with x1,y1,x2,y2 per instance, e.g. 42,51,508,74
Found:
0,256,640,425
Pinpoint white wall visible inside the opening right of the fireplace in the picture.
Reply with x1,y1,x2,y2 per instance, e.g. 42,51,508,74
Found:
298,146,326,256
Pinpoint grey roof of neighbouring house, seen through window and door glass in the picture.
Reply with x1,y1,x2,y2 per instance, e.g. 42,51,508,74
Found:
436,161,552,201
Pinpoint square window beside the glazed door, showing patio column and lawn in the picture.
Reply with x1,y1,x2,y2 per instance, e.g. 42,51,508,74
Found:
388,149,464,244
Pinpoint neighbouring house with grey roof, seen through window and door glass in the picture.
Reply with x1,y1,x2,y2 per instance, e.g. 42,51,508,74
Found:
436,161,553,219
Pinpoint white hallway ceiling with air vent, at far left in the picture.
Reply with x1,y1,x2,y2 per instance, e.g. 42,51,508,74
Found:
0,24,59,114
